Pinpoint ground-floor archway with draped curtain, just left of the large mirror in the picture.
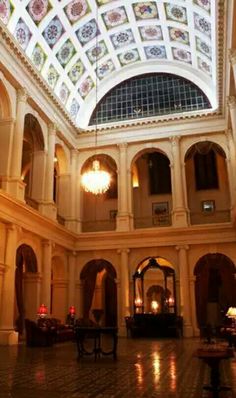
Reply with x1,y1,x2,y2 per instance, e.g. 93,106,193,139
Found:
80,259,117,326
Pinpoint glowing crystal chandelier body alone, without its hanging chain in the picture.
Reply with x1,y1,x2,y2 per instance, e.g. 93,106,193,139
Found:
82,160,111,195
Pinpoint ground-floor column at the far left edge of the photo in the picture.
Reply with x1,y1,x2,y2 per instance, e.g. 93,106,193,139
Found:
0,225,18,345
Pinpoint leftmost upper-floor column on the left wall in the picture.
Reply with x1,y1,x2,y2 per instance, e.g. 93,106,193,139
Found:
7,88,28,201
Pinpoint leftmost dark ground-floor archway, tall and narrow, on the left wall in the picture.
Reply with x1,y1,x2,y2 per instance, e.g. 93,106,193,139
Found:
14,244,38,334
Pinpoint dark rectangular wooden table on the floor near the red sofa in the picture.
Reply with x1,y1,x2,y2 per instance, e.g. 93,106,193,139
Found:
75,326,118,360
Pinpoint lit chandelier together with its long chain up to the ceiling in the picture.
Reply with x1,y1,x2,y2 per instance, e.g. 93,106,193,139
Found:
81,6,111,195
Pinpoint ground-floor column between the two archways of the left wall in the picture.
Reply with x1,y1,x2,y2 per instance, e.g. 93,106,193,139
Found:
40,240,52,313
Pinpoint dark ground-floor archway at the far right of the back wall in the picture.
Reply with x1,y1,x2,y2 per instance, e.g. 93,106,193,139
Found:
194,253,236,328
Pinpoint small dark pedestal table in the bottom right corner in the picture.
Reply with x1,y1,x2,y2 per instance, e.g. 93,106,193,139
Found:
194,347,234,398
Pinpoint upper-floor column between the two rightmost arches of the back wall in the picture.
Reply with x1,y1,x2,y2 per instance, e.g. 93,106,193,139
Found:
170,136,188,227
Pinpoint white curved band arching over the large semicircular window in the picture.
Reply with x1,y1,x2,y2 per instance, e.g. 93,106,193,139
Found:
77,61,218,128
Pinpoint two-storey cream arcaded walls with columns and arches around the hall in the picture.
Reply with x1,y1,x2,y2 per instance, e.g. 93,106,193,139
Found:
0,2,236,344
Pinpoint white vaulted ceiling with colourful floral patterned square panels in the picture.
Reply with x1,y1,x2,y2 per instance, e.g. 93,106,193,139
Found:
0,0,217,125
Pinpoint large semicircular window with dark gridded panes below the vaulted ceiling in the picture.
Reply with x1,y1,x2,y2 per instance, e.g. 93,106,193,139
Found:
89,73,211,125
